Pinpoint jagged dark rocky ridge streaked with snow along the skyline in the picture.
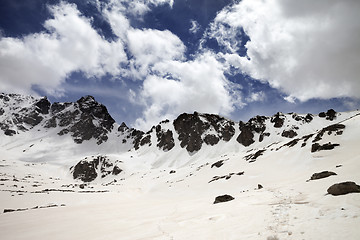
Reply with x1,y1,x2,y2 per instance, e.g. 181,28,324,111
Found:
0,94,348,153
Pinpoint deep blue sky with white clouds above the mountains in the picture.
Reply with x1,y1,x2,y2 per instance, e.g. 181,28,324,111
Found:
0,0,360,130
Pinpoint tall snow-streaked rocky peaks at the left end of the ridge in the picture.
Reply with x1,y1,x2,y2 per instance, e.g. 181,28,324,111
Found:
0,94,115,144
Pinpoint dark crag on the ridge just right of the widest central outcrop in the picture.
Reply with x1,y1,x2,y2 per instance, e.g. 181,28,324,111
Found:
236,116,270,147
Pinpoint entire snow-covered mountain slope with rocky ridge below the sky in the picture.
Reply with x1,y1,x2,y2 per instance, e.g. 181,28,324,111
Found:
0,94,360,239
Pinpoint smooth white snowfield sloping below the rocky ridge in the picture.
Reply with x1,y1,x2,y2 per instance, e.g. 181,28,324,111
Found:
0,112,360,240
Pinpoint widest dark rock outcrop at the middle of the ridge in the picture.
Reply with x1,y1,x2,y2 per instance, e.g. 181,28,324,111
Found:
174,112,235,152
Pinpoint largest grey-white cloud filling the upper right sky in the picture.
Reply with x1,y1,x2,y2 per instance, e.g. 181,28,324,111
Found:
207,0,360,101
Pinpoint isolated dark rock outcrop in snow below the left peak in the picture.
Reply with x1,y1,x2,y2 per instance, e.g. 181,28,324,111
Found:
70,156,122,182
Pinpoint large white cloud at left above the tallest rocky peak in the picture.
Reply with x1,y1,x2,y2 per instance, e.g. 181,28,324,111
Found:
0,2,126,95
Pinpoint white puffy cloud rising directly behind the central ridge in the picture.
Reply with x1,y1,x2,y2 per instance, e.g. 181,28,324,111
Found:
136,52,242,129
